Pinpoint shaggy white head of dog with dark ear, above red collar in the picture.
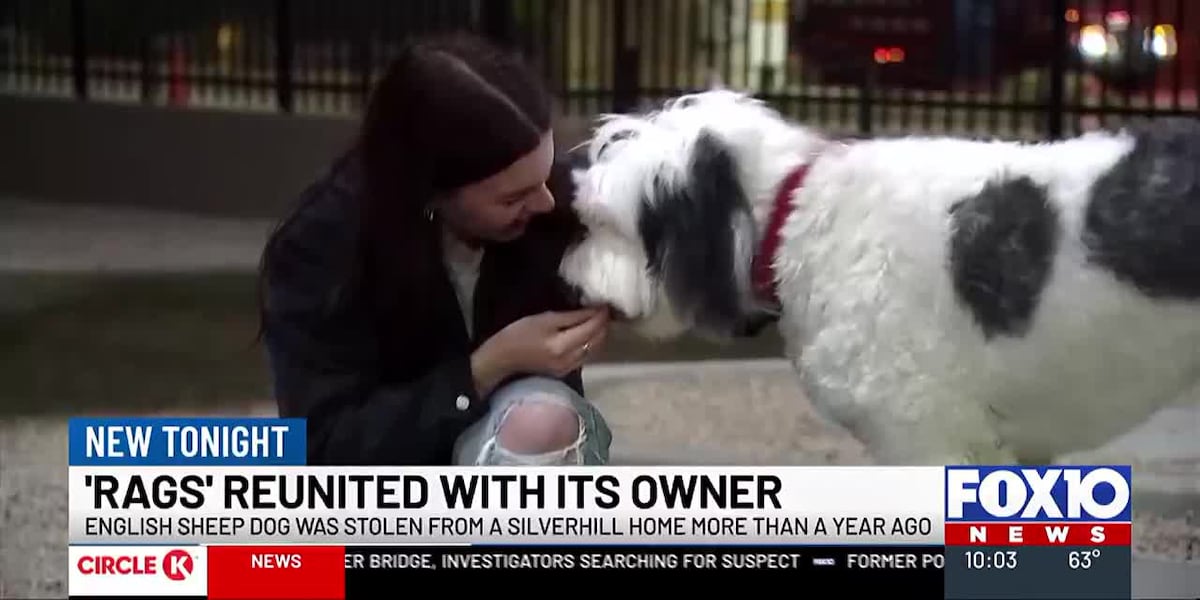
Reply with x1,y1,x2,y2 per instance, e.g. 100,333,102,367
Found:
560,90,812,338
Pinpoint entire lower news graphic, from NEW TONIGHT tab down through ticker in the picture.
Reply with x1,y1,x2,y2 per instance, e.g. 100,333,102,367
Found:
68,419,1133,599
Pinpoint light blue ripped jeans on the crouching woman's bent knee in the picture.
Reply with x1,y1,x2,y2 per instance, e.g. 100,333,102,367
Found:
454,377,612,467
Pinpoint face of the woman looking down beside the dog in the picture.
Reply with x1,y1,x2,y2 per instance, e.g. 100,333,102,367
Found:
438,133,554,242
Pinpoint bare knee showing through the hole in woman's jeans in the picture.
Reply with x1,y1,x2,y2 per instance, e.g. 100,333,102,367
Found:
496,396,582,455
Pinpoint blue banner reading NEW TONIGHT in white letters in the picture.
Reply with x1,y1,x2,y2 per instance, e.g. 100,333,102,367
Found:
67,418,307,467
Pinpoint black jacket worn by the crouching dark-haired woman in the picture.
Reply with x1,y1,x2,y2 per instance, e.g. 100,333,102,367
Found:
263,150,583,464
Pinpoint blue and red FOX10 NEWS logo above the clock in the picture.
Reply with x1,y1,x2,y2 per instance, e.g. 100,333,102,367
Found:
946,466,1133,546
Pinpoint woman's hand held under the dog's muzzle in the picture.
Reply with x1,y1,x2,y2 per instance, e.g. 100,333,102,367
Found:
470,308,608,395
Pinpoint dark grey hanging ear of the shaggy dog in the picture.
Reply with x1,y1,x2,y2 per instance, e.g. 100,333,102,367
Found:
638,131,752,336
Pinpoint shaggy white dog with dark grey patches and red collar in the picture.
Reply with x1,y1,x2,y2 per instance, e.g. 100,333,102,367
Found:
560,90,1200,464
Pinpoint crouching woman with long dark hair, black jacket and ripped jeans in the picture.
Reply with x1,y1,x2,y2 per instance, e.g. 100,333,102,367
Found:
255,36,610,464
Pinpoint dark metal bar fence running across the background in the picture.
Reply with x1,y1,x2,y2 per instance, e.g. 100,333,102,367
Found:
0,0,1200,138
